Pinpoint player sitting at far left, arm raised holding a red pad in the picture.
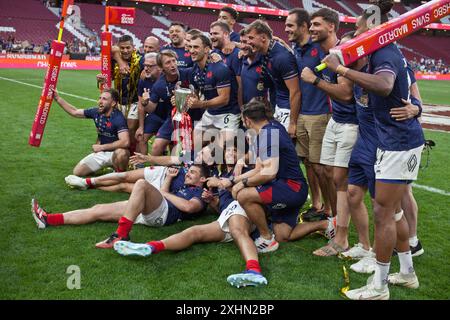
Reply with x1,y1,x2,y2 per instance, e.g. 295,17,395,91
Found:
54,89,130,176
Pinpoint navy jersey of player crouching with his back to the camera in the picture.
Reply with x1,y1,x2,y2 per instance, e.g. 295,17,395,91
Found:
257,120,304,181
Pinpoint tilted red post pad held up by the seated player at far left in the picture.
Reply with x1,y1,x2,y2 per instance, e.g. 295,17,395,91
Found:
28,40,65,147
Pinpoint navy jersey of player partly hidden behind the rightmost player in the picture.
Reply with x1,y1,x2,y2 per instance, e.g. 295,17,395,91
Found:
350,80,378,165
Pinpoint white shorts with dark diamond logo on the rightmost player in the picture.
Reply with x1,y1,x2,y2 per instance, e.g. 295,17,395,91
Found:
374,146,423,180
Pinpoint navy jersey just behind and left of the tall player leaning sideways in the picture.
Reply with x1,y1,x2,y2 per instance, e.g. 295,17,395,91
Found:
241,55,273,104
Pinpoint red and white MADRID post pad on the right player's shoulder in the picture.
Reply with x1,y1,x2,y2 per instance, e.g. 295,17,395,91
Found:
330,0,450,65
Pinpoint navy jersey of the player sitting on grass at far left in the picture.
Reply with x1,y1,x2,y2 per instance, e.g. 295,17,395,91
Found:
84,107,128,144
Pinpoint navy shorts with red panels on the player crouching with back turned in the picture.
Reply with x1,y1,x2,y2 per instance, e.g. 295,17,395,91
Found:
256,179,308,228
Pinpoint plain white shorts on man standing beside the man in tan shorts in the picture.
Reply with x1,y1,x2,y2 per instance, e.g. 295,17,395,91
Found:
320,118,359,168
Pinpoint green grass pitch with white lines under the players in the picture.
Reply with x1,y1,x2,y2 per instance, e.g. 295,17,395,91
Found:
0,69,450,300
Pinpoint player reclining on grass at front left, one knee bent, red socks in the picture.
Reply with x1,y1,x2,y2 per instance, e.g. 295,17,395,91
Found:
31,164,209,249
